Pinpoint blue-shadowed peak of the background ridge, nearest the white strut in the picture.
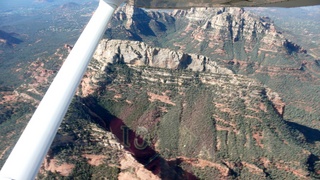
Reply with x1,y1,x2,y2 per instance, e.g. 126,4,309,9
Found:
105,5,175,43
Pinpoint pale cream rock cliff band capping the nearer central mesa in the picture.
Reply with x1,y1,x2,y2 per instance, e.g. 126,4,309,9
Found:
94,39,232,74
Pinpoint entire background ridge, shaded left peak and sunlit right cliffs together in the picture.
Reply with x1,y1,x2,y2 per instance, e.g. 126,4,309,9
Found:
111,5,306,61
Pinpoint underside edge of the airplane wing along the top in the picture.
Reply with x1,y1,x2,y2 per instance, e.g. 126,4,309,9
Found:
128,0,320,9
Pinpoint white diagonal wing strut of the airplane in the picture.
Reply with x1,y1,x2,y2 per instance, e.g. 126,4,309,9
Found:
0,0,123,180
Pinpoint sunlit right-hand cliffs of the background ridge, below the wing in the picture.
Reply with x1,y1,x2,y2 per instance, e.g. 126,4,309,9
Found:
172,8,306,61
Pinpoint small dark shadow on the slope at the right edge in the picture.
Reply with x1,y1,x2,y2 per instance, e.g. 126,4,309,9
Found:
286,121,320,143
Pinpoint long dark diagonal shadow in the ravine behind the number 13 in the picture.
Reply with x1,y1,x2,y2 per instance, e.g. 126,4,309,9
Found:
81,97,198,180
